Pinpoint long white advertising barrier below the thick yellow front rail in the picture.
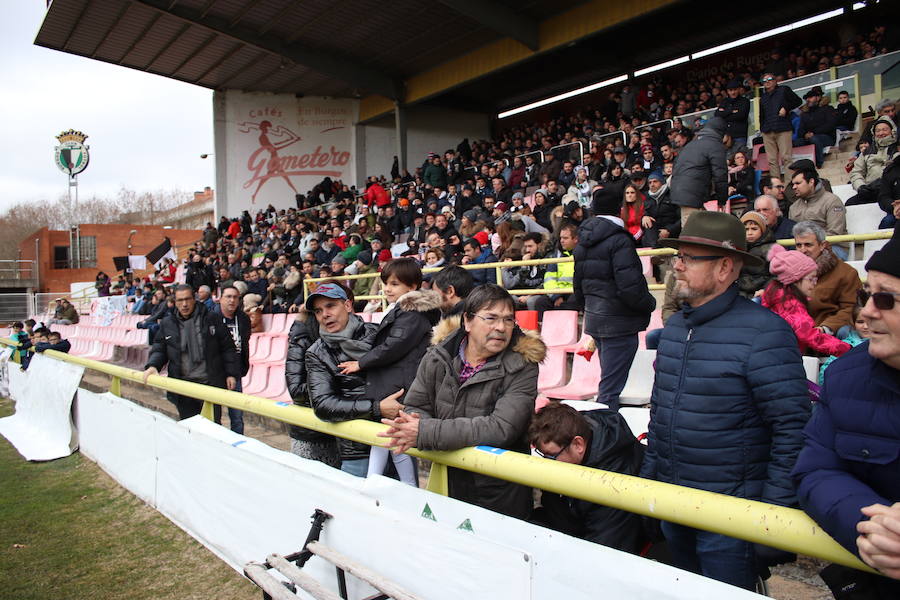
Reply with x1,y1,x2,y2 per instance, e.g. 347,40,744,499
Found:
78,390,759,600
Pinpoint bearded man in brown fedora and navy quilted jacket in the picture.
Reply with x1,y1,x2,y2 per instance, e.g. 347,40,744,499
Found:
641,211,810,589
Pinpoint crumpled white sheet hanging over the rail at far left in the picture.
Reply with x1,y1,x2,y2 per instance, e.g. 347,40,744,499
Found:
0,354,84,460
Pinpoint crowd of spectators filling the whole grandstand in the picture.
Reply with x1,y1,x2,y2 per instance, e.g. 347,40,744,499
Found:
10,26,900,592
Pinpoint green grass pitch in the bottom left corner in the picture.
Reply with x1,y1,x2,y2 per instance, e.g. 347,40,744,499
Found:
0,399,262,600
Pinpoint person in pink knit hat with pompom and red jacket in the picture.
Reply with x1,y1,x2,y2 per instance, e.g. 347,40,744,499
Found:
762,244,851,356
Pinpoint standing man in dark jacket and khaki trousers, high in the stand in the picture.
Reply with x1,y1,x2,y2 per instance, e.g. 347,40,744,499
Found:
759,73,803,179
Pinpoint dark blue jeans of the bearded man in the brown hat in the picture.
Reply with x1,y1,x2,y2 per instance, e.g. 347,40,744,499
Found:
660,521,757,590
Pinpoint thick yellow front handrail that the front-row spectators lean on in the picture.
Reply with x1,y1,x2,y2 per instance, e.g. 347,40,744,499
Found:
0,338,874,572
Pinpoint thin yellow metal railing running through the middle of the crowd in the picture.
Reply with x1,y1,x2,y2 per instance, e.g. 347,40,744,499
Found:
303,229,893,300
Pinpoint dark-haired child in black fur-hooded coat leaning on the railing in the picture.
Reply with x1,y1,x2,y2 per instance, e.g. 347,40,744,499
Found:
338,258,441,486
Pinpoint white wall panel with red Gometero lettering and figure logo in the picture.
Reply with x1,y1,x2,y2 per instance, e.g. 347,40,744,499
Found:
216,90,359,217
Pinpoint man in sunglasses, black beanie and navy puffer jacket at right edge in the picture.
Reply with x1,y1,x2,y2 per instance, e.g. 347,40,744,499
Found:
793,229,900,598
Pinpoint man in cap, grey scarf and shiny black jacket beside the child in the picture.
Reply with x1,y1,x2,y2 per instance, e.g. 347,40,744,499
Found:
304,283,402,477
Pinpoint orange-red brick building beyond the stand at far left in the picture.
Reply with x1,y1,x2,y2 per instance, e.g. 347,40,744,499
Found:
19,224,202,293
